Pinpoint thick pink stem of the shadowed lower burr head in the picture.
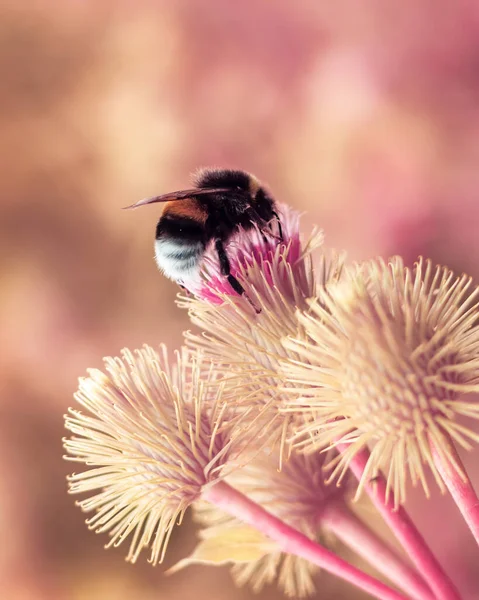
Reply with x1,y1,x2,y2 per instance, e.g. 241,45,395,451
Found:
320,503,434,600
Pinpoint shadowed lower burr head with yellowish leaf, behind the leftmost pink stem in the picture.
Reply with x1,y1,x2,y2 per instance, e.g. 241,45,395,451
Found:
172,452,348,598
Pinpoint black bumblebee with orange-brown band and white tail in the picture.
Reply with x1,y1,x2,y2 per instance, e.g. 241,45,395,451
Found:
127,169,282,295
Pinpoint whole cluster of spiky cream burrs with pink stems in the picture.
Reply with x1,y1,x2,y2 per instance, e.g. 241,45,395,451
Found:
65,199,479,598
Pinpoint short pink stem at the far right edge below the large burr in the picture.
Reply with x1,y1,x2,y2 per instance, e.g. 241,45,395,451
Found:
429,437,479,545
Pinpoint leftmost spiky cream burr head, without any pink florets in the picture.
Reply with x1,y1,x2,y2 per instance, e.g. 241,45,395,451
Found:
64,347,248,563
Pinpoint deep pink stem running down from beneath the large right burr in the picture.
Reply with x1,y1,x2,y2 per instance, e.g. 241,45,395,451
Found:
337,444,460,600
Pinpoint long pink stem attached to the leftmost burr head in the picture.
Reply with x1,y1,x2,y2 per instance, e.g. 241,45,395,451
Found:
201,481,404,600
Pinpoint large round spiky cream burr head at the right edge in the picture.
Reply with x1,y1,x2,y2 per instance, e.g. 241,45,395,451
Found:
284,258,479,502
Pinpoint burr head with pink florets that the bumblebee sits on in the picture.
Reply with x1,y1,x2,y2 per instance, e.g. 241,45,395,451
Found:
180,206,342,458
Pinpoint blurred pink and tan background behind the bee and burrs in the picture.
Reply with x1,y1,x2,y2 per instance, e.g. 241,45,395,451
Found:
0,0,479,600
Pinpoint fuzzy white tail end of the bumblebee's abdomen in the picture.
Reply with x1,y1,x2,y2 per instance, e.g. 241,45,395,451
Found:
155,238,205,283
